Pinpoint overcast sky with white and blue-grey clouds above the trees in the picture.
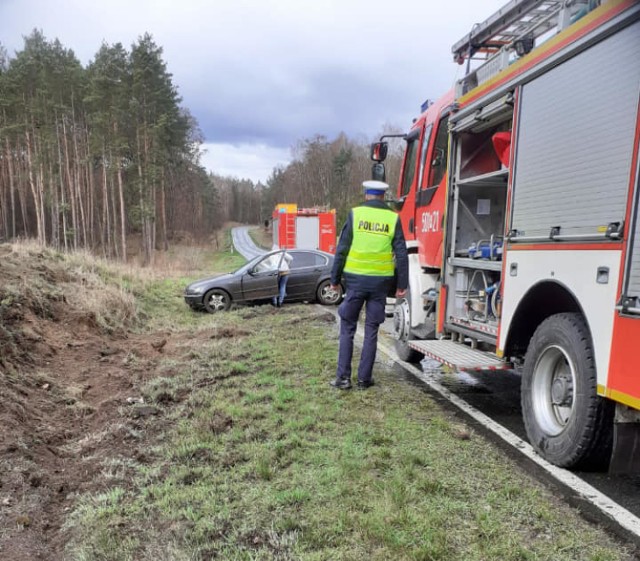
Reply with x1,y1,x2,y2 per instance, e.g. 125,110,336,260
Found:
0,0,506,182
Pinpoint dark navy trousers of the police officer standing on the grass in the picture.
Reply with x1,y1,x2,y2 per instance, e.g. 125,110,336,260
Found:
336,282,388,382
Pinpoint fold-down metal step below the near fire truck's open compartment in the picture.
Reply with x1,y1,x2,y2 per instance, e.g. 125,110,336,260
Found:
409,340,513,371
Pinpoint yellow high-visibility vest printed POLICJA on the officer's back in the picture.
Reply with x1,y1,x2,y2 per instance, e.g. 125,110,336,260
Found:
344,206,398,277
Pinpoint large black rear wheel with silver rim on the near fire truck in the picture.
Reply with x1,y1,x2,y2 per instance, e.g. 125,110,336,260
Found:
521,313,614,470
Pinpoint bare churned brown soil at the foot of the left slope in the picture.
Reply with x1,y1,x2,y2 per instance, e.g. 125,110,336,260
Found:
0,314,175,561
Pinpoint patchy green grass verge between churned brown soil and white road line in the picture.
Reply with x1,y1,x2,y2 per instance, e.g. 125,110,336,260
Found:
62,296,632,561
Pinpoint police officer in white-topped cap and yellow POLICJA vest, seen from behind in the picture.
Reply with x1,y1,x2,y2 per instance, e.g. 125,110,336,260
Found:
331,181,409,390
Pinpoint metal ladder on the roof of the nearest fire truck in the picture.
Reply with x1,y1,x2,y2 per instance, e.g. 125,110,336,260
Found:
451,0,600,97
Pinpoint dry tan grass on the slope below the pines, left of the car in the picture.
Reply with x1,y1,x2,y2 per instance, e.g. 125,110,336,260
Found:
0,225,245,340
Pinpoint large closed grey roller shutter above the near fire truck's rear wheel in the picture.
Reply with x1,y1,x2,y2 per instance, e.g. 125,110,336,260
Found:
511,22,640,238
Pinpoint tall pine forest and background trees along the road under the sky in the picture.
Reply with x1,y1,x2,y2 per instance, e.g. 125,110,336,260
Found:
0,30,400,265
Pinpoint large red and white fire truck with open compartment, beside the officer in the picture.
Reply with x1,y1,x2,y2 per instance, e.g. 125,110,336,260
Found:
371,0,640,473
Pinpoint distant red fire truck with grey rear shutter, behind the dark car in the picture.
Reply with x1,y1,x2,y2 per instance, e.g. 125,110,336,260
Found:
272,203,336,253
